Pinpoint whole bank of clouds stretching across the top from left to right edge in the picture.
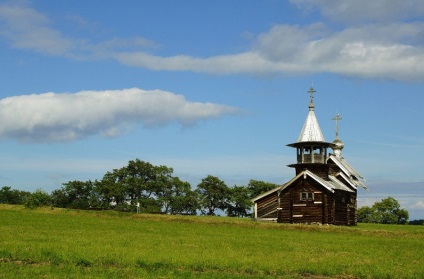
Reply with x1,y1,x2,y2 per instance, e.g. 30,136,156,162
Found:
0,0,424,81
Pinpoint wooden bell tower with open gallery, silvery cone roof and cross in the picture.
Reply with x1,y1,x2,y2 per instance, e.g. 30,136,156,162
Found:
287,87,332,179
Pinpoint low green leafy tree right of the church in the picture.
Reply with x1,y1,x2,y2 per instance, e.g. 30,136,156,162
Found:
358,197,409,224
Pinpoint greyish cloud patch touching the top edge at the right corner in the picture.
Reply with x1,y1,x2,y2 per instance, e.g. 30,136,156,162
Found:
290,0,424,23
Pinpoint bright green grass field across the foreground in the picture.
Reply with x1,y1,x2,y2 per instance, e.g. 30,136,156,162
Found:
0,205,424,279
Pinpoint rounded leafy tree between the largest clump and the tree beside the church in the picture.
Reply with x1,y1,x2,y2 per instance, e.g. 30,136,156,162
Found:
196,175,229,215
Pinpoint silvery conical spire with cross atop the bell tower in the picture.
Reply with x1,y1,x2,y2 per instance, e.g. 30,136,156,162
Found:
297,87,325,142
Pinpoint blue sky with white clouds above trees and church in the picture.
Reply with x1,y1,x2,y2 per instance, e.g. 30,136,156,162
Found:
0,0,424,219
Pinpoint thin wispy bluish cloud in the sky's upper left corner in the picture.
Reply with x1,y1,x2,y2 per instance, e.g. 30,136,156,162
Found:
0,1,156,59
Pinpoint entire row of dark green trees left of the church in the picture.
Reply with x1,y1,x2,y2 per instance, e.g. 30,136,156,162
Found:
0,159,278,217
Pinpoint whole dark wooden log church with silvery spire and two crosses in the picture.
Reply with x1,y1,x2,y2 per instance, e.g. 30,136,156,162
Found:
252,87,367,226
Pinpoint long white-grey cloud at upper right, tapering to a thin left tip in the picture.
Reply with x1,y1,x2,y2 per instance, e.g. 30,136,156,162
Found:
115,23,424,80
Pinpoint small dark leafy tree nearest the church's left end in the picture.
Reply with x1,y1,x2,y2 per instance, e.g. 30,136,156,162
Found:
227,186,253,217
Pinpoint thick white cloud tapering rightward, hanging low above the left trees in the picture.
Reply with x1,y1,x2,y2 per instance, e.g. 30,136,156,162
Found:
0,88,237,142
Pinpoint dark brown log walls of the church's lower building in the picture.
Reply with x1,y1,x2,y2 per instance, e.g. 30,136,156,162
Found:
255,173,357,226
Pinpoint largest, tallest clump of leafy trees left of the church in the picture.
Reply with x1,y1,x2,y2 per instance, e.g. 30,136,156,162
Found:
52,159,198,214
